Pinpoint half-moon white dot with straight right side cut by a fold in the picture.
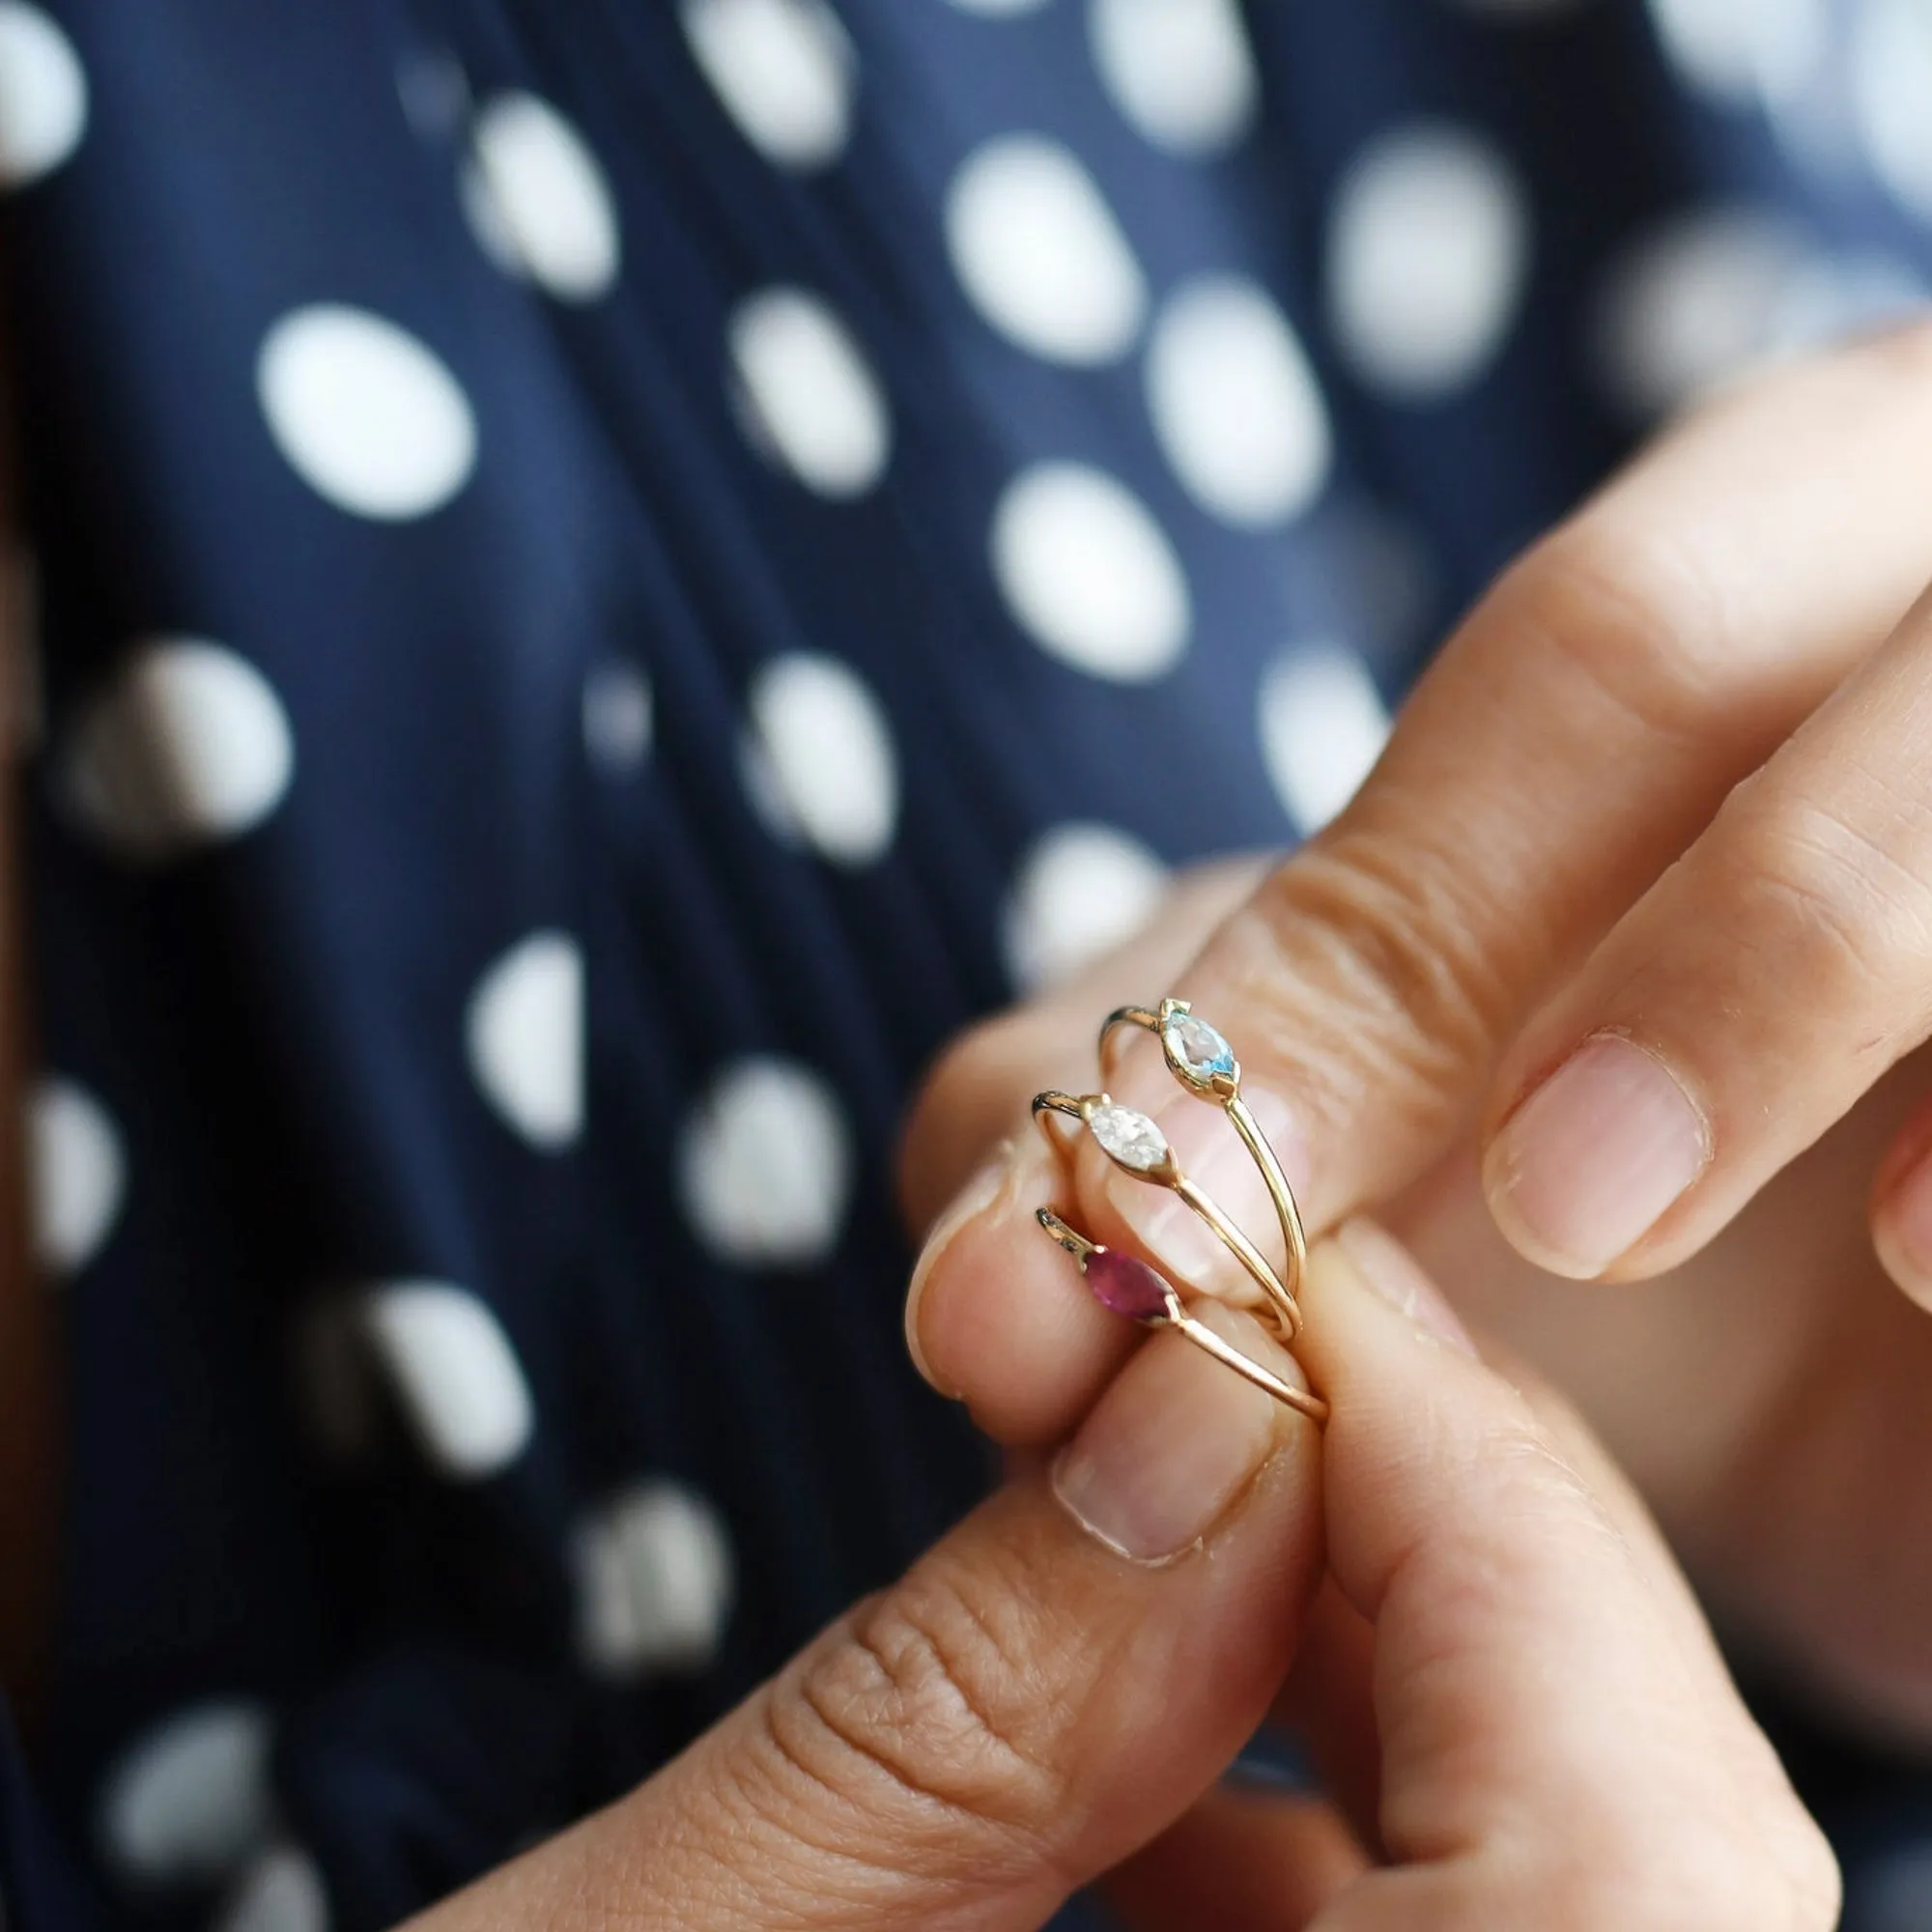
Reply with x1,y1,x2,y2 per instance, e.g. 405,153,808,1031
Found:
468,933,583,1151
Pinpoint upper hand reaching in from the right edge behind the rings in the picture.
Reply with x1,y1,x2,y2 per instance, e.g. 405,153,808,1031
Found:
906,328,1932,1733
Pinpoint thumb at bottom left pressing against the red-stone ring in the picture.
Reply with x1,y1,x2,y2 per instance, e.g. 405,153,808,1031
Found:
410,1310,1321,1932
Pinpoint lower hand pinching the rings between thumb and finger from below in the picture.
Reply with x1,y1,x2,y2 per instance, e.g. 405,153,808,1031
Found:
404,1227,1837,1932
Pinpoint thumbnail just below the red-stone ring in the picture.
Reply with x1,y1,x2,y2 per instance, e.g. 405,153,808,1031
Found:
1053,1300,1298,1563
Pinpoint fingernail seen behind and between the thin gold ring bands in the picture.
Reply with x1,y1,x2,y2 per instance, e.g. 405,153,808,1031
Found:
1107,1070,1308,1306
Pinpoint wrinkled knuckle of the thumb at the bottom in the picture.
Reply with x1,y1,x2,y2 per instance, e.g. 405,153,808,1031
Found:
767,1561,1068,1868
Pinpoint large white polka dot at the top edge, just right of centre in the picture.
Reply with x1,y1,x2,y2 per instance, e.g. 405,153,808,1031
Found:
1092,0,1260,155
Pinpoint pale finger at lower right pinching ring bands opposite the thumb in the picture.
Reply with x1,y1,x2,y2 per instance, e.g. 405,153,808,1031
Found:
1308,1223,1837,1932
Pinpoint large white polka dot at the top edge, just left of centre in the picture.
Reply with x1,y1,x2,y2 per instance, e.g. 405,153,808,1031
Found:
684,0,856,168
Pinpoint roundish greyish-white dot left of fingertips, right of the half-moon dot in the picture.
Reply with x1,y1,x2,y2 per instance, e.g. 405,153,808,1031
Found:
678,1057,852,1267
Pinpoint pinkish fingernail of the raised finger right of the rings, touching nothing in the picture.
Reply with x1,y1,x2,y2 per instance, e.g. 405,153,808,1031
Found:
1482,1034,1710,1279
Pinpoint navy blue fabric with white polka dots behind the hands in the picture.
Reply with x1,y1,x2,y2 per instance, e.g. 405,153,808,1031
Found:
0,0,1932,1932
